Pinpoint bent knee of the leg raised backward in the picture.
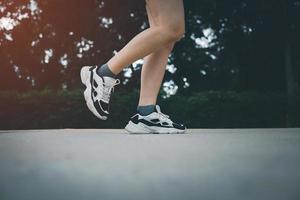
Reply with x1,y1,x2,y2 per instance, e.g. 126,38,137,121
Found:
164,23,185,42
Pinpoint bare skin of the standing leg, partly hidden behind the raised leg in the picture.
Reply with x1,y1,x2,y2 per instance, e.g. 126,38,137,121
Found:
139,3,178,106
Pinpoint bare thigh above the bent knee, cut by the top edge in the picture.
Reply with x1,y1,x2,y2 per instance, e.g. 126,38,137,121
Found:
146,0,185,26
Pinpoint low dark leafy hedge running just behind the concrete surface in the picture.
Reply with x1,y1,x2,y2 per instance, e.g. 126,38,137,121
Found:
0,90,300,129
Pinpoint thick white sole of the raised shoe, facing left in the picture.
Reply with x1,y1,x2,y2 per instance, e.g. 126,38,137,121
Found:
80,67,107,120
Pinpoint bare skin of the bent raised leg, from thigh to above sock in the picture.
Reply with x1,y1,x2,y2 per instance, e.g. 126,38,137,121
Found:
107,0,185,74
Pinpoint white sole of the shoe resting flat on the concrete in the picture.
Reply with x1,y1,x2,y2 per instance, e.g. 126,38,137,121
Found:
125,121,186,134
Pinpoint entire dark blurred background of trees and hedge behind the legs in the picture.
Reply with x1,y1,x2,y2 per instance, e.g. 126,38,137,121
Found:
0,0,300,129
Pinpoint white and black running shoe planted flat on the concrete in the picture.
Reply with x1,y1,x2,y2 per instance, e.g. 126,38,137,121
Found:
125,105,186,134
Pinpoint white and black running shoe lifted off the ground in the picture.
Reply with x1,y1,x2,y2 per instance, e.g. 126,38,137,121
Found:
80,66,120,120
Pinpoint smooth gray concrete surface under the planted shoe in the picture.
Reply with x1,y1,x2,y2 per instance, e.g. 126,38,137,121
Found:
0,129,300,200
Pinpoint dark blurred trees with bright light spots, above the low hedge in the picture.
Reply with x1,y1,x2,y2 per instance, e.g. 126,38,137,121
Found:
0,0,300,99
